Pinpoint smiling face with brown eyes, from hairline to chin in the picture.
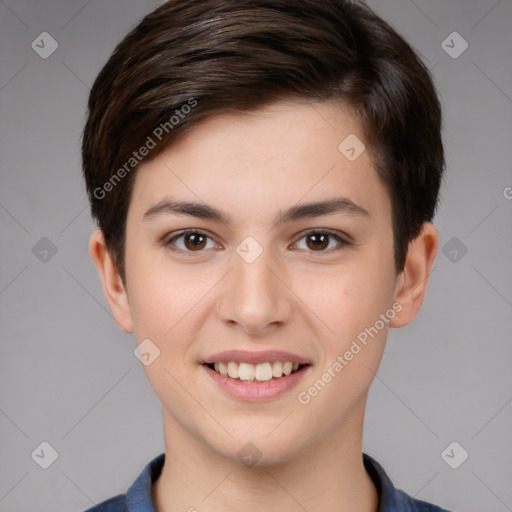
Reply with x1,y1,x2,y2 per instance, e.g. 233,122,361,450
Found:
95,98,428,464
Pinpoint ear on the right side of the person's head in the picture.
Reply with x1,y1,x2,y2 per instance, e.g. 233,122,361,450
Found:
390,222,439,327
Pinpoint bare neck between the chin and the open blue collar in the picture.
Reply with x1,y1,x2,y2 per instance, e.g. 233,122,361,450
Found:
152,404,378,512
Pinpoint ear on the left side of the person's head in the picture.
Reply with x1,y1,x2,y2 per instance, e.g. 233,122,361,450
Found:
89,229,133,333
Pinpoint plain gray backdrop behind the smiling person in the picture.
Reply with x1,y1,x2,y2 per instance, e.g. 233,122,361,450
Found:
0,0,512,512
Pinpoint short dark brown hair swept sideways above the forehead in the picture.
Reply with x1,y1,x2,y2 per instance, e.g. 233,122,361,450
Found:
82,0,445,281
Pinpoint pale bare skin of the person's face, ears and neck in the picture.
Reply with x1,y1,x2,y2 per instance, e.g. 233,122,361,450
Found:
89,101,438,512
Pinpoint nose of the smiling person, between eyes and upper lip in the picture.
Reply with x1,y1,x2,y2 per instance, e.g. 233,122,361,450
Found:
217,243,293,337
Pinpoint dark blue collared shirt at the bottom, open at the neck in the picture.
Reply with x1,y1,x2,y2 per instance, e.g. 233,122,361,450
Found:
84,453,448,512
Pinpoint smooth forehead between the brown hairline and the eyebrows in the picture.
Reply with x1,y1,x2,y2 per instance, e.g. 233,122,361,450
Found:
126,101,389,225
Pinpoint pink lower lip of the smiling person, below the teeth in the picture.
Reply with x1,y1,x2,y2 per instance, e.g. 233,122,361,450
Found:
202,364,310,402
